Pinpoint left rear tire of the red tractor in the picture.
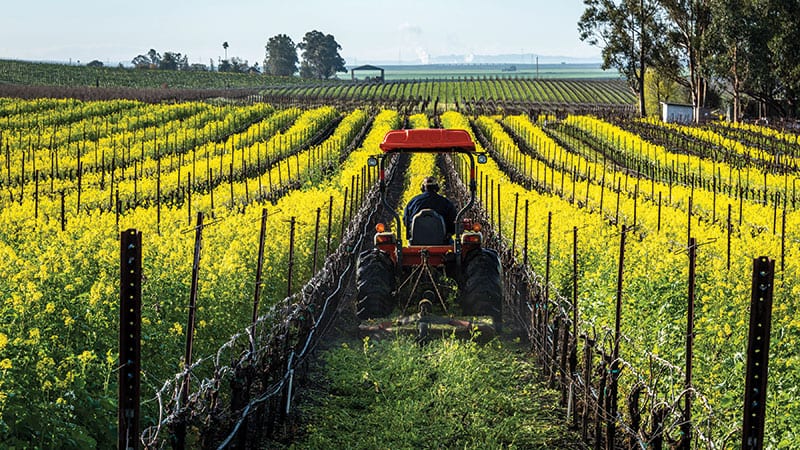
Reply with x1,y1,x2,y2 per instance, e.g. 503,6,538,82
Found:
356,248,397,320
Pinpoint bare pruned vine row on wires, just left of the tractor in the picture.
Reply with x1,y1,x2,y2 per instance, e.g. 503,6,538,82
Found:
141,131,398,448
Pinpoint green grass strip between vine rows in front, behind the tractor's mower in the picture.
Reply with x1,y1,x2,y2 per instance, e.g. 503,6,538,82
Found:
280,337,583,449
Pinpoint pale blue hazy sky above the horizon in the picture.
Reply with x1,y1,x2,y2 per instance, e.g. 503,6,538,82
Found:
0,0,600,65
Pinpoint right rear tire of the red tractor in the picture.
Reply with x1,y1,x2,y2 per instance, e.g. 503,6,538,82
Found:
460,248,503,325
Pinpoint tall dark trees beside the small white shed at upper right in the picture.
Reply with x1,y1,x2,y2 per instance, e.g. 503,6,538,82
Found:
578,0,800,120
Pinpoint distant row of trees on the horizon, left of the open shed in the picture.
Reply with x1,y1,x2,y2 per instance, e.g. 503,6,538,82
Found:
131,30,347,79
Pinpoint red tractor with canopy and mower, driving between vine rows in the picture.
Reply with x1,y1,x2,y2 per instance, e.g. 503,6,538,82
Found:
356,129,503,340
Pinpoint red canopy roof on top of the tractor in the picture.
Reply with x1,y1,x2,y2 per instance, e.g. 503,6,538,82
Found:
380,128,475,153
